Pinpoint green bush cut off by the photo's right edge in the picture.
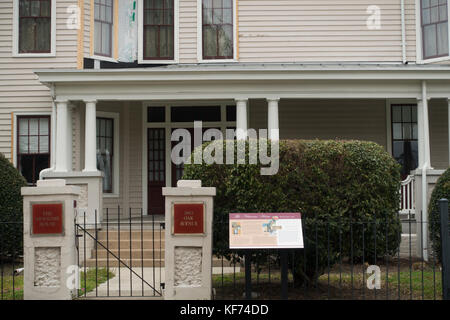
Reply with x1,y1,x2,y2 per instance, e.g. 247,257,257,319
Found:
428,168,450,262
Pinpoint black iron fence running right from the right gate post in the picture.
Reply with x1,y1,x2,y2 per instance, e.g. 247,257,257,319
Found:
213,202,450,300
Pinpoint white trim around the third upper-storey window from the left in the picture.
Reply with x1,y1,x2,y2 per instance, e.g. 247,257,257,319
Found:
137,0,180,64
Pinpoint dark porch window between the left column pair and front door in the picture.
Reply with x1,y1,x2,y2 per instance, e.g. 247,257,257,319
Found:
97,117,115,193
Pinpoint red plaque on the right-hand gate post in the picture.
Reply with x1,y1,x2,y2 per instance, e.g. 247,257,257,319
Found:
172,203,205,235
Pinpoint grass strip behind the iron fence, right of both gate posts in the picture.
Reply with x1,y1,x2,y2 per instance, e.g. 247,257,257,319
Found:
213,267,442,300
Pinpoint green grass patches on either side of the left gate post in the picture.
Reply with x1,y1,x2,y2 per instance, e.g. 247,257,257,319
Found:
0,268,114,300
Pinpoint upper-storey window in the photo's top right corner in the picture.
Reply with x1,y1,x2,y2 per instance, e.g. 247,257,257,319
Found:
421,0,449,59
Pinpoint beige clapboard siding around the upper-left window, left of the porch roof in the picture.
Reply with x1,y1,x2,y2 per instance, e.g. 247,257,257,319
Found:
0,0,78,159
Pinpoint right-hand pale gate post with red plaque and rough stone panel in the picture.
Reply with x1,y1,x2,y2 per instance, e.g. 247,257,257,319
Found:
163,180,216,300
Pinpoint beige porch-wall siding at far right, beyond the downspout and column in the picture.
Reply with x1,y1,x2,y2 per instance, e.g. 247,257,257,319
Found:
428,100,449,169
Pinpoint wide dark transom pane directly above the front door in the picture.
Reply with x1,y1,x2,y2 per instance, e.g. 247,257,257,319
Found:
171,106,221,122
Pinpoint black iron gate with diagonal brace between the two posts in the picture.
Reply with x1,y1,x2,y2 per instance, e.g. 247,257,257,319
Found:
75,207,165,298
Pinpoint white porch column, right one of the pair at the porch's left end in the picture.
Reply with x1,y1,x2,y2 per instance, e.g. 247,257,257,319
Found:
83,100,97,172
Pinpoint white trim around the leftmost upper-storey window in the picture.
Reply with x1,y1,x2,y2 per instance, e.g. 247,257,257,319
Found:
12,0,56,58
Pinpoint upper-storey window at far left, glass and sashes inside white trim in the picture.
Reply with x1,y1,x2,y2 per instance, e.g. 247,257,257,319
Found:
18,0,52,53
